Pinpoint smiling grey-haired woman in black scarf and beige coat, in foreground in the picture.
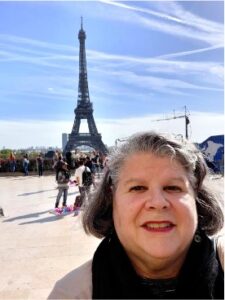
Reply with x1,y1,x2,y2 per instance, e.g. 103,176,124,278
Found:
49,132,224,299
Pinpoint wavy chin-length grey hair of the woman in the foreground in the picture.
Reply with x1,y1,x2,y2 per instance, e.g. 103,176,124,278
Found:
82,131,224,238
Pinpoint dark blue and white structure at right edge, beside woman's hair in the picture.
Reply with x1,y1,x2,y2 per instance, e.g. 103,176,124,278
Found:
198,135,224,174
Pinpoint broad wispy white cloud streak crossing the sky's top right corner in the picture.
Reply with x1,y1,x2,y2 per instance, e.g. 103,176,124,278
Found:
98,0,223,45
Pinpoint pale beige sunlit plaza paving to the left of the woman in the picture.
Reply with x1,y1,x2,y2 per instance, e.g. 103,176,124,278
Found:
0,175,100,299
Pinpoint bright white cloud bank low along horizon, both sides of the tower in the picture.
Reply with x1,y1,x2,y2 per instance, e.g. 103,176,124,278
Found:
0,112,224,149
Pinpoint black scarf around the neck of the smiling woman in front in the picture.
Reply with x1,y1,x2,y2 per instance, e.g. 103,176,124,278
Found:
92,234,224,299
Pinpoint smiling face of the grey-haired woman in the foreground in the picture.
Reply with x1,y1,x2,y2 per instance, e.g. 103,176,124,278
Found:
113,152,198,278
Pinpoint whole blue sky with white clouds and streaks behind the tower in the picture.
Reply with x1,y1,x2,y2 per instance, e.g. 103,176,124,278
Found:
0,0,224,148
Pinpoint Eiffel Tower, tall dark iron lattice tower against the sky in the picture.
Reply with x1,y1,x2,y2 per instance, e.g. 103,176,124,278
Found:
64,18,108,154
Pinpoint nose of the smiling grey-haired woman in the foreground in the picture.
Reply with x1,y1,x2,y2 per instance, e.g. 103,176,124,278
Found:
145,188,169,209
